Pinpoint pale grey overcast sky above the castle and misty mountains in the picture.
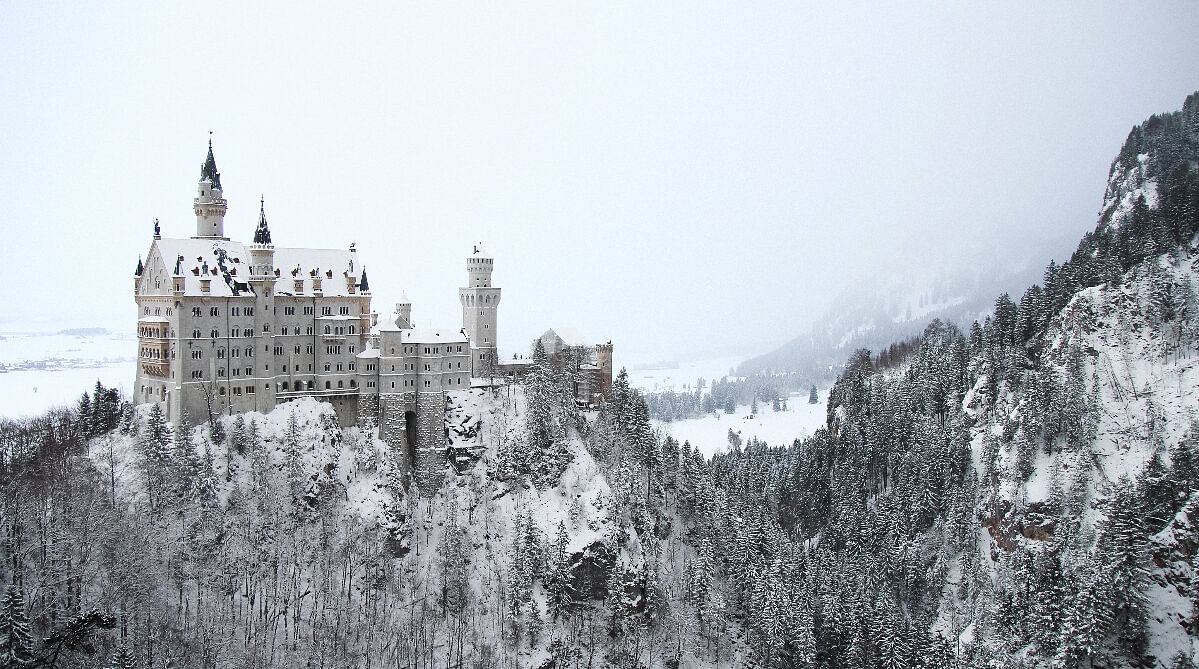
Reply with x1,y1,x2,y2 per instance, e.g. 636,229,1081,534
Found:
0,0,1199,362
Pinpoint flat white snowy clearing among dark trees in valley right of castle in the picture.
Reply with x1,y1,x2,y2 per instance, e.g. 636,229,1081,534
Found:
655,391,827,456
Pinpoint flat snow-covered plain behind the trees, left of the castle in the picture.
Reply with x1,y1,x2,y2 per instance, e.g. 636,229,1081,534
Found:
0,331,137,417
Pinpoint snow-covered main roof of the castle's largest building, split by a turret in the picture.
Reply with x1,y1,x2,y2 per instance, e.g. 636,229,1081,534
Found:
151,237,362,297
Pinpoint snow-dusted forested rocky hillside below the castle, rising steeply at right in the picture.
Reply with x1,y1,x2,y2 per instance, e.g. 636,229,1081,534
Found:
0,95,1199,669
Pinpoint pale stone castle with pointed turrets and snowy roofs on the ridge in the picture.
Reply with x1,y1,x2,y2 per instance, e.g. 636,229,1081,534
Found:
133,139,611,490
